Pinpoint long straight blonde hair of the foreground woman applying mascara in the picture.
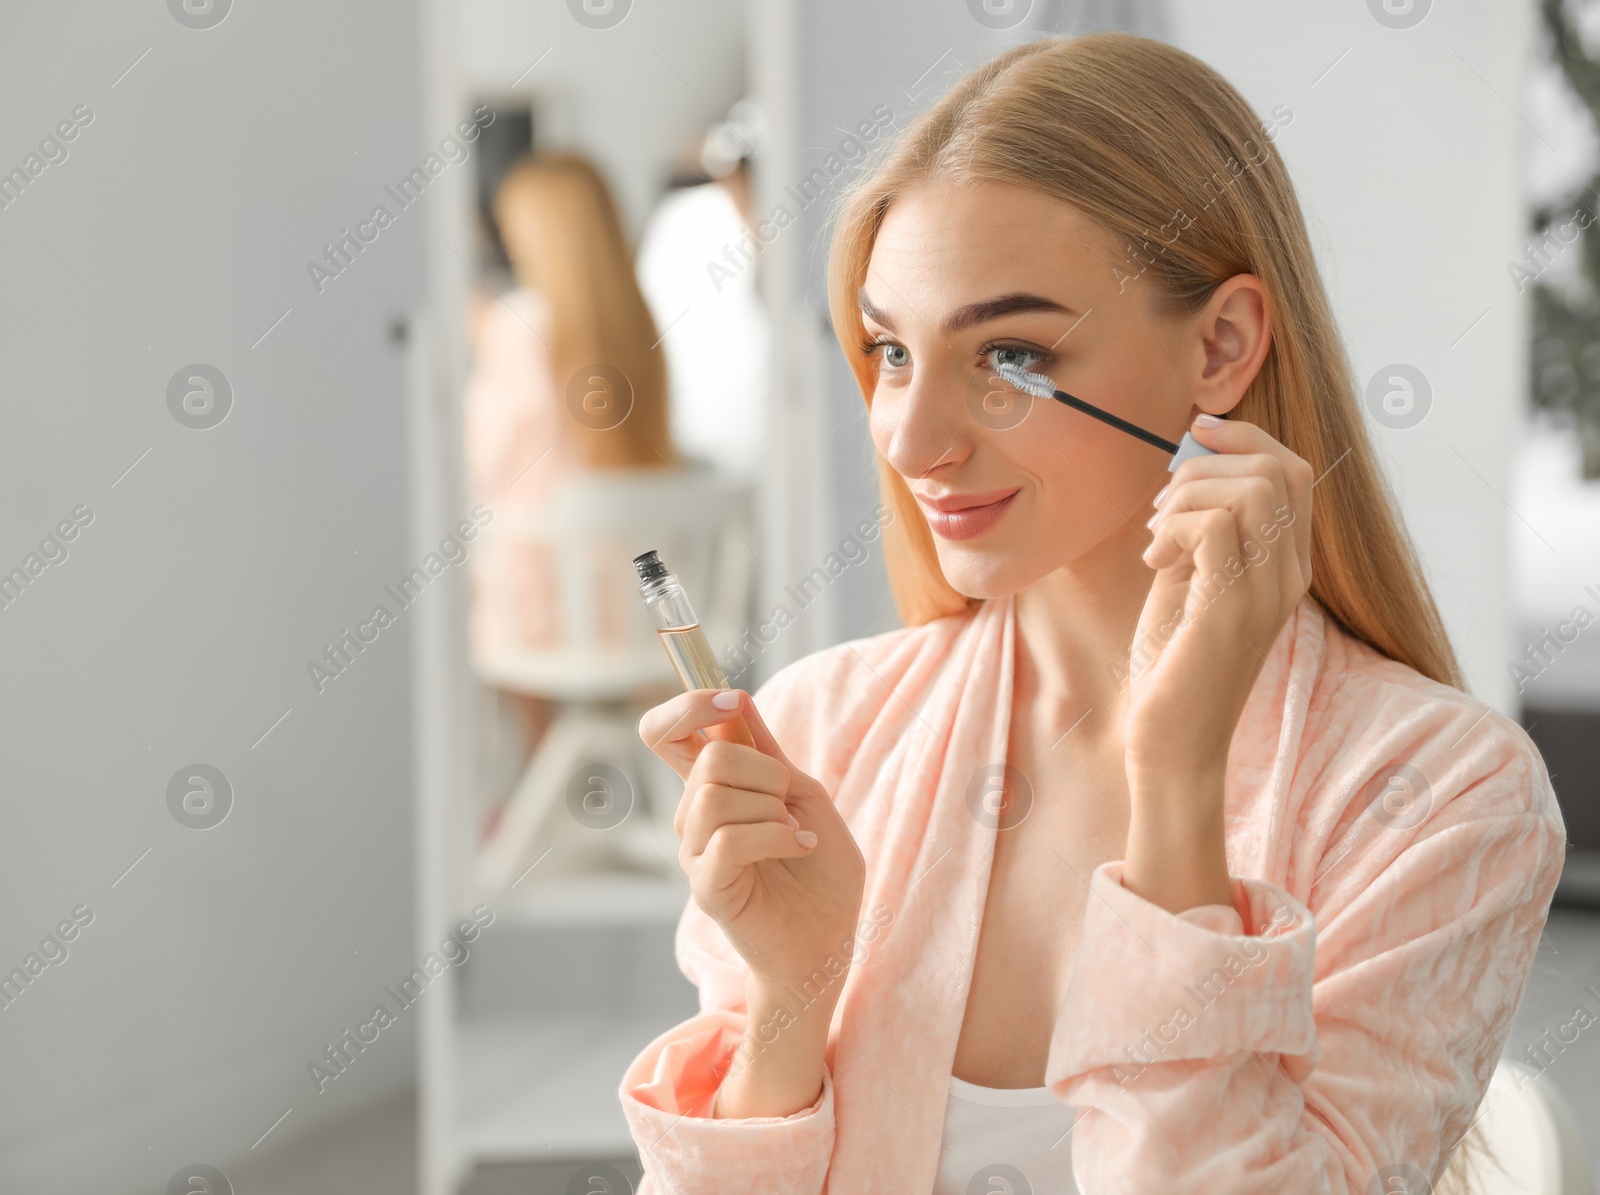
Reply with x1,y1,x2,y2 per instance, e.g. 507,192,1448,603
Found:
827,32,1486,1192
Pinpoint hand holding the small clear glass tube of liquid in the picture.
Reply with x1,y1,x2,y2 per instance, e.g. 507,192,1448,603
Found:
638,689,866,998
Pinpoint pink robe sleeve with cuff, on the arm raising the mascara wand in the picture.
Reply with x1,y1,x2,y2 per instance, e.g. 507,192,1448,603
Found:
1046,693,1566,1195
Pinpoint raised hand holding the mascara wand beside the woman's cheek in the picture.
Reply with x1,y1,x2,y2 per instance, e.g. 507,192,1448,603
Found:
1123,416,1314,783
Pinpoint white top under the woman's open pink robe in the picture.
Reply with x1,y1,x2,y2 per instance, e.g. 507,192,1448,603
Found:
933,1075,1078,1195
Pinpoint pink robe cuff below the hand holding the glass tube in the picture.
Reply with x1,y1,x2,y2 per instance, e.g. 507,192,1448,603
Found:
618,1009,834,1195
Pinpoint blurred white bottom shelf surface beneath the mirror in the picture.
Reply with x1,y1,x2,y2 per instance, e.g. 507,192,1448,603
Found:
450,1016,672,1163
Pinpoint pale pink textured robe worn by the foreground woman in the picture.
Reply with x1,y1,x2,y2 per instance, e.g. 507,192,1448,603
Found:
618,585,1566,1195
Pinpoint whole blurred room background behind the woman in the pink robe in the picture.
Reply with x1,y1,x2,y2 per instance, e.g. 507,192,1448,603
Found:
0,0,1600,1195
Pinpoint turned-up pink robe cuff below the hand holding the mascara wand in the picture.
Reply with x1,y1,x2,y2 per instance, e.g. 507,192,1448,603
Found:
1045,859,1318,1104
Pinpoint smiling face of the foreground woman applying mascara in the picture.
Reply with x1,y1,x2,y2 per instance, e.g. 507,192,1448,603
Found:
861,182,1206,597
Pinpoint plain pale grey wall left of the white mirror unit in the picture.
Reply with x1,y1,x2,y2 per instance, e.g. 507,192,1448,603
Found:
0,0,428,1193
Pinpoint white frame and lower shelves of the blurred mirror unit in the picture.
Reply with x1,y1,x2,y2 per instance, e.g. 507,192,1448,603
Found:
408,0,829,1195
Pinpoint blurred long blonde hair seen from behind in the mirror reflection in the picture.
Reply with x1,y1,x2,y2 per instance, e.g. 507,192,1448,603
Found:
494,154,678,469
